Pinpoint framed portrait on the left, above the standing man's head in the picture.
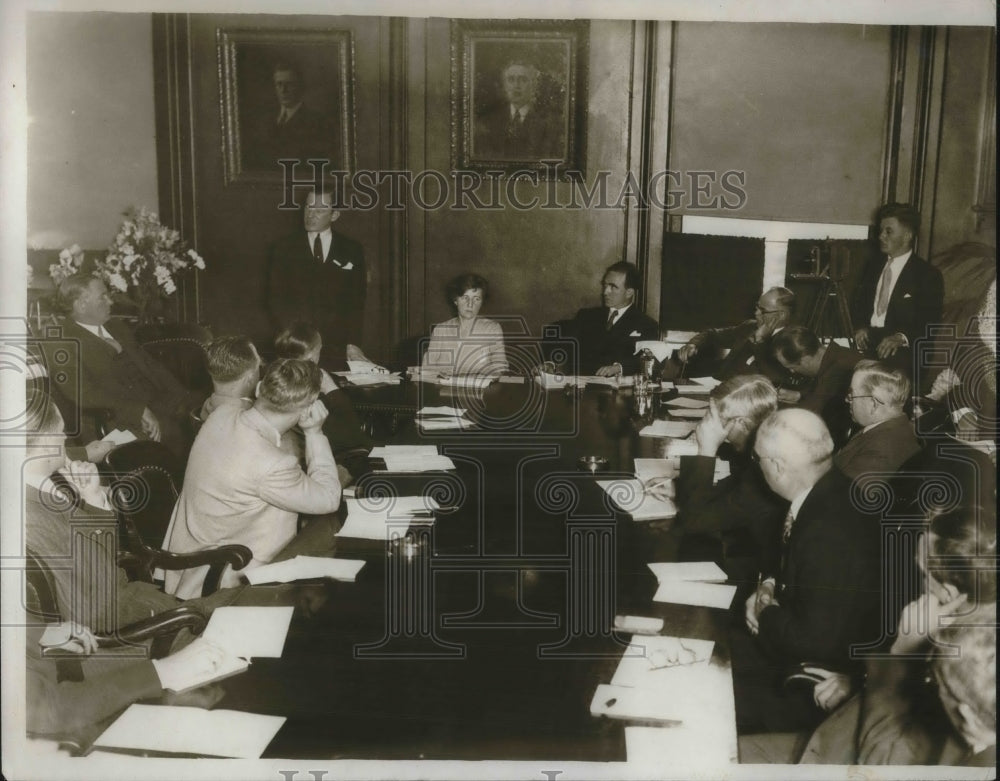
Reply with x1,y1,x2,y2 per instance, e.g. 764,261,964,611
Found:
216,28,355,185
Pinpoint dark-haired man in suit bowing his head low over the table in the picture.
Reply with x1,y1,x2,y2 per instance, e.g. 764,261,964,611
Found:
771,325,861,448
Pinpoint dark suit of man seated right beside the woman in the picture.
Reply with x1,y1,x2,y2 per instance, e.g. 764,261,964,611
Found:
562,304,660,374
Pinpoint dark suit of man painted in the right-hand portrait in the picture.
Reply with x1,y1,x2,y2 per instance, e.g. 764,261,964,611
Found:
473,102,567,160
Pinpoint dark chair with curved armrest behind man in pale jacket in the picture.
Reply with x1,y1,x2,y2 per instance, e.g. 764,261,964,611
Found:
108,441,253,596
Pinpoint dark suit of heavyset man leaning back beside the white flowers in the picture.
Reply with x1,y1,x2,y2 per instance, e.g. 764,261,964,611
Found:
42,318,201,455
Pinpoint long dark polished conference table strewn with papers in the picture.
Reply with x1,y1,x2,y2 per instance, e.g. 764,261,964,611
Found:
216,379,735,762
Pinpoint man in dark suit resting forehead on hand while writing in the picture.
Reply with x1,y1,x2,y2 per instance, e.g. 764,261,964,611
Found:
651,374,788,579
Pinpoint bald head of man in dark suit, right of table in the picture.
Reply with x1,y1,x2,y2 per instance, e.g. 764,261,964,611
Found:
754,409,833,501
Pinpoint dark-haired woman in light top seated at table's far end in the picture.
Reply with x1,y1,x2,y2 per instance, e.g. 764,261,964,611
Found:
423,274,509,376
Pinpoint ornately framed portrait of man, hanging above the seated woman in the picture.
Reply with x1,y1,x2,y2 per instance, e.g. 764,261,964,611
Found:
451,19,590,179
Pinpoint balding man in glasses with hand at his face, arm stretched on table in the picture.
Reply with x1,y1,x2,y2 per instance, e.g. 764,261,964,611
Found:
677,287,795,386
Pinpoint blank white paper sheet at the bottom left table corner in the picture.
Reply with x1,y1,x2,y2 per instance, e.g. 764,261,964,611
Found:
94,704,285,759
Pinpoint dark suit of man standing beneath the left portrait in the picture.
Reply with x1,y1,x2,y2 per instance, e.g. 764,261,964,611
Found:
267,229,367,362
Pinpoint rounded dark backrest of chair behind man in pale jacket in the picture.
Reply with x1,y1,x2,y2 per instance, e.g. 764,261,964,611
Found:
107,440,183,555
